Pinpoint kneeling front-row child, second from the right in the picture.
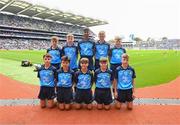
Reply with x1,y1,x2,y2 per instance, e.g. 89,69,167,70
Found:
94,58,114,110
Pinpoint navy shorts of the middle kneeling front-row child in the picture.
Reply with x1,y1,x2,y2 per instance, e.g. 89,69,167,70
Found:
75,88,92,104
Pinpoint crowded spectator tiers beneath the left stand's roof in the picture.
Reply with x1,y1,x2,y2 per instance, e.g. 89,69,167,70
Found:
0,13,97,49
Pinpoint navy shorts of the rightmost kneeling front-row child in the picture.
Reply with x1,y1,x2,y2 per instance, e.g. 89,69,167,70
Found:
117,89,133,103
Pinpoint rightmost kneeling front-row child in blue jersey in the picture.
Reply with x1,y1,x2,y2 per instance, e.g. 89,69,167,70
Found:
114,54,136,110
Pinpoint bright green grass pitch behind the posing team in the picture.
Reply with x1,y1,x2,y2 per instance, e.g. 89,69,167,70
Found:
0,50,180,87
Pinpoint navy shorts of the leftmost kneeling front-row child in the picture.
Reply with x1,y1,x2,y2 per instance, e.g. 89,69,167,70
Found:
38,86,56,100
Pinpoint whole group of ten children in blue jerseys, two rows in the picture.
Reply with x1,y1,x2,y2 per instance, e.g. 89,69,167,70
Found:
38,28,136,110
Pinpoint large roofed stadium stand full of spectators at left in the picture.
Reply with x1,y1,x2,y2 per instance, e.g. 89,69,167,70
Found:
0,0,107,49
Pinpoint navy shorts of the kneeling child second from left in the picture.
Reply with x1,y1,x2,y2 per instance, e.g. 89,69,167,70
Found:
57,87,73,104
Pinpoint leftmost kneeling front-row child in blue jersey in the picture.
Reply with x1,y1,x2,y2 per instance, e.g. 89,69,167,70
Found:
38,54,56,108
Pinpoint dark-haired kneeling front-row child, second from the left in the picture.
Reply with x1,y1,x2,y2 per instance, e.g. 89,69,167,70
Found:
57,56,74,110
